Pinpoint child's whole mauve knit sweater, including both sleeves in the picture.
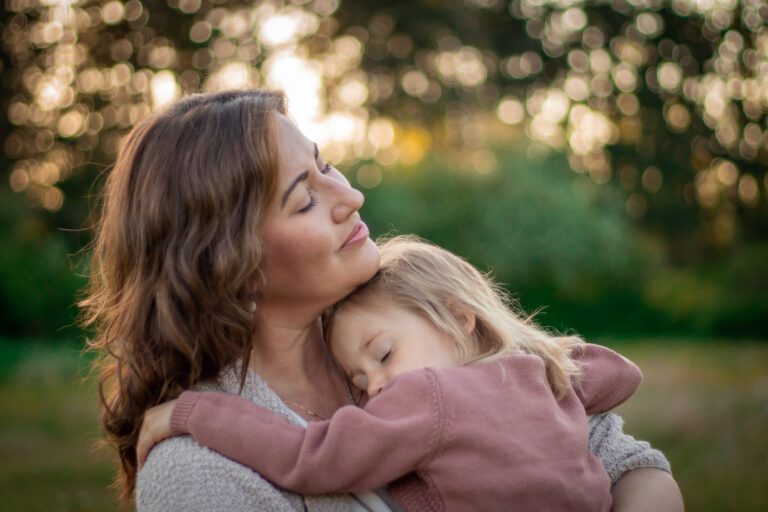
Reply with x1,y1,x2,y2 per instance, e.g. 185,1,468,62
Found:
172,345,641,511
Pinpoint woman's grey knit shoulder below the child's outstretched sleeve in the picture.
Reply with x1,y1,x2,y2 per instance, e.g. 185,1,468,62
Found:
136,436,303,512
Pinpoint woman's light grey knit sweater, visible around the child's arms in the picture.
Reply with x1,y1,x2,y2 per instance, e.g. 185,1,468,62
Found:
136,371,670,512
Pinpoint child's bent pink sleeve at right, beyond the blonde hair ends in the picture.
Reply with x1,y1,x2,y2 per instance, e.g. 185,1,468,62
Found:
572,343,643,414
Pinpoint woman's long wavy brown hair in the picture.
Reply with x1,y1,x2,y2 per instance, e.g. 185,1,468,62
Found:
80,90,286,503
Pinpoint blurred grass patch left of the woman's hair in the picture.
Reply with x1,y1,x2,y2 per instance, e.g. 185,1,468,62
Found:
0,341,117,512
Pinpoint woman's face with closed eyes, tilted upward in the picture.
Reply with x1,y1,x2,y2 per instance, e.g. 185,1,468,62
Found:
259,114,379,314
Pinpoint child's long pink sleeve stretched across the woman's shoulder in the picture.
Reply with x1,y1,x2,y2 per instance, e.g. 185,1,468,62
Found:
171,370,442,494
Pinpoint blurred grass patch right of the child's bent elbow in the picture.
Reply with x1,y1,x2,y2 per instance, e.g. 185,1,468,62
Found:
613,340,768,511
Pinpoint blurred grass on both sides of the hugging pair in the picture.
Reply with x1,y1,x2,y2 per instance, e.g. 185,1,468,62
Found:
0,339,768,512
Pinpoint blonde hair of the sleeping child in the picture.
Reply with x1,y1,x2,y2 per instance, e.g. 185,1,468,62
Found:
325,235,583,399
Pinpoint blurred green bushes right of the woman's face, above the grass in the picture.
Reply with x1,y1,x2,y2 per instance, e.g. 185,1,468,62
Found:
352,149,768,337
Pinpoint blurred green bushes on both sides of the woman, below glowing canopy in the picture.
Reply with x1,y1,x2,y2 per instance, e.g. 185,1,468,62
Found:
0,148,768,339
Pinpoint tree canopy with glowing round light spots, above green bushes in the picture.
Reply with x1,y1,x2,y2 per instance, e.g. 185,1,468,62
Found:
0,0,768,340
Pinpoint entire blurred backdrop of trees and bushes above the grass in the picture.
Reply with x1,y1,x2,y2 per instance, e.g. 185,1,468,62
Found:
0,0,768,337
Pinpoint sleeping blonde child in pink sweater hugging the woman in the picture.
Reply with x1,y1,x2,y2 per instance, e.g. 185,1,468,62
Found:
139,237,641,511
